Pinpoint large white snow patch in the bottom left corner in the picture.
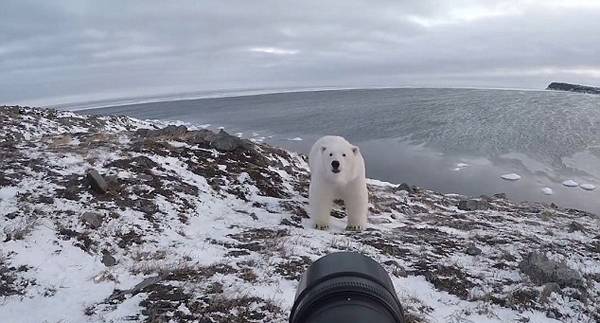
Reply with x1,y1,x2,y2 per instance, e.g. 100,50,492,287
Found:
0,223,125,323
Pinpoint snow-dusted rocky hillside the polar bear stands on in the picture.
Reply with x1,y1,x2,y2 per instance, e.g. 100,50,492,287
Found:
0,107,600,322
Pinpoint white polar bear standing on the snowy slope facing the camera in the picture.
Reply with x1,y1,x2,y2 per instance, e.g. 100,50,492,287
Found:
308,136,369,230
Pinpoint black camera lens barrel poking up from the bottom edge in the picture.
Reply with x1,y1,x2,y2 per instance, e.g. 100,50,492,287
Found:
290,252,404,323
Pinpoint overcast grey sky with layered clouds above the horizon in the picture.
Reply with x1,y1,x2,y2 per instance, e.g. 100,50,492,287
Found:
0,0,600,105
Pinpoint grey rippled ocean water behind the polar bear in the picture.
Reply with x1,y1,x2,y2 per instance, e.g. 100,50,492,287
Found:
82,88,600,214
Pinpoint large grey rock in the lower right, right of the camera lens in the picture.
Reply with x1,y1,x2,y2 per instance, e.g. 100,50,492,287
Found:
519,251,583,288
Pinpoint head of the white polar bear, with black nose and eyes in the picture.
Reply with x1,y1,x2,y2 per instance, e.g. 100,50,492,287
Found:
320,143,362,184
